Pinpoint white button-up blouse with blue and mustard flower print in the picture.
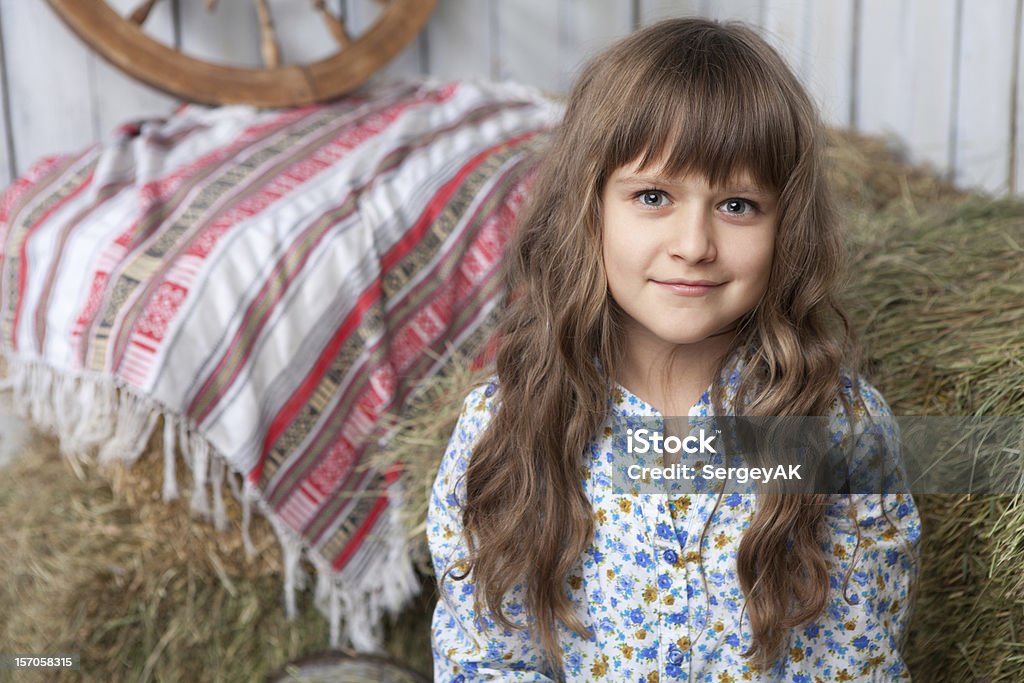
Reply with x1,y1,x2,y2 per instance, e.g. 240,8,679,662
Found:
427,371,921,683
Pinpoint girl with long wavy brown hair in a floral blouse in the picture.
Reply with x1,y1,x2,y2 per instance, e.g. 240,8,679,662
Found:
428,19,919,682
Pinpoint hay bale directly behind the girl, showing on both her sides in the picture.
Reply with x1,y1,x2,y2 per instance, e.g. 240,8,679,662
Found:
379,131,1024,681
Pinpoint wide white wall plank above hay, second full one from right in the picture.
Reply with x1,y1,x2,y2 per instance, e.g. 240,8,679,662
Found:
855,0,956,172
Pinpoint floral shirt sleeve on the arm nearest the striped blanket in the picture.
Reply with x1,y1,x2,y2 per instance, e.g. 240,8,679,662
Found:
427,383,554,683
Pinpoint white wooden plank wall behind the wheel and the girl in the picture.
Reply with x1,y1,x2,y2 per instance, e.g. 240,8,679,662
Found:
0,0,1024,195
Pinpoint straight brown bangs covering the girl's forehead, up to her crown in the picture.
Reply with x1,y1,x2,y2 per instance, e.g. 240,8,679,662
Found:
604,24,808,191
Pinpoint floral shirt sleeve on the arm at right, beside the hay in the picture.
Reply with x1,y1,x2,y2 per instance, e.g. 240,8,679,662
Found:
790,382,921,681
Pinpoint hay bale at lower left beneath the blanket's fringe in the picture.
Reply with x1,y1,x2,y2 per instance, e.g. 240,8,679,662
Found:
0,430,431,682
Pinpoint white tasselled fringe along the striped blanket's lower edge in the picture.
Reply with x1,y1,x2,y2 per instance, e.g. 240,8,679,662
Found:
0,355,420,653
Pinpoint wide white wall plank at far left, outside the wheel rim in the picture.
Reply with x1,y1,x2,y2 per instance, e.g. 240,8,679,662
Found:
3,0,97,174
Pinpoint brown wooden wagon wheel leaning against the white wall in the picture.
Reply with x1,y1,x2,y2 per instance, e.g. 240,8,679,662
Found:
47,0,436,106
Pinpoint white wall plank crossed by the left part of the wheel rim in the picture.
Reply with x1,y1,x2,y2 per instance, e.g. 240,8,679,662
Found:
91,0,178,139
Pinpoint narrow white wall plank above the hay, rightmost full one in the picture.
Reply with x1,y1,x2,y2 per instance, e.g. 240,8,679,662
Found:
953,0,1017,194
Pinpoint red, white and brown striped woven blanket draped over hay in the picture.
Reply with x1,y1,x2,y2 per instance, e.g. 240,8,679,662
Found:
0,83,560,650
